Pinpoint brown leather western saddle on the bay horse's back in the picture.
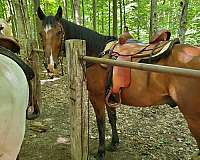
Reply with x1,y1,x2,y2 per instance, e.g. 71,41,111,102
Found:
106,30,179,106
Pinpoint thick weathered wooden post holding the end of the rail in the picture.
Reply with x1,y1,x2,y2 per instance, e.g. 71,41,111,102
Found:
65,40,88,160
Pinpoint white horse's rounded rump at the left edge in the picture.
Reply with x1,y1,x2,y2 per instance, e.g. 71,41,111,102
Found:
0,54,29,160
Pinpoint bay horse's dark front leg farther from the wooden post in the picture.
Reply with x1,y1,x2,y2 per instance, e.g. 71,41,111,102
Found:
106,106,119,151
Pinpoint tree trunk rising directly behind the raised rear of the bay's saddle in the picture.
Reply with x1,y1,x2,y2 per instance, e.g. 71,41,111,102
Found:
149,0,157,40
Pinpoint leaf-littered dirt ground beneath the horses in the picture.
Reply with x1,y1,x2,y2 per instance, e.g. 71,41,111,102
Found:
20,71,197,160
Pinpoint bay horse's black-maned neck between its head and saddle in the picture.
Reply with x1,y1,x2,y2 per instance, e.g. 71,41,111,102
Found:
61,19,117,56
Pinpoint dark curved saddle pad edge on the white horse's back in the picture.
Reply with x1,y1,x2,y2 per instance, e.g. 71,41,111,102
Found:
0,46,35,80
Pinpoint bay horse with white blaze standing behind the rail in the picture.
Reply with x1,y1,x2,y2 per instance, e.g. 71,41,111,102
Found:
38,7,200,160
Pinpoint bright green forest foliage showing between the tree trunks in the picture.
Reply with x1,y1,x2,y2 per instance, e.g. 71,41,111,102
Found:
0,0,200,44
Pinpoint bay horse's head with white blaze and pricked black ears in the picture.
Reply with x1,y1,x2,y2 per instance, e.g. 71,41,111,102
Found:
37,7,65,77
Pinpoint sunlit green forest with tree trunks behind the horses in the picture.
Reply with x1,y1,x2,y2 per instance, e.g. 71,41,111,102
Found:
0,0,200,55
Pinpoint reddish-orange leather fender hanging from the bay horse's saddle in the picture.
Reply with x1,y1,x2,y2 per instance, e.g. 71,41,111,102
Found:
112,56,131,93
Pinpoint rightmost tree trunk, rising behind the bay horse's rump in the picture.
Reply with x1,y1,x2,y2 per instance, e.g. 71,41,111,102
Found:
178,0,188,43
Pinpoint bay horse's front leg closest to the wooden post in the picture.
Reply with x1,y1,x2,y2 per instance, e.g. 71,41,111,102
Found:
89,95,105,160
